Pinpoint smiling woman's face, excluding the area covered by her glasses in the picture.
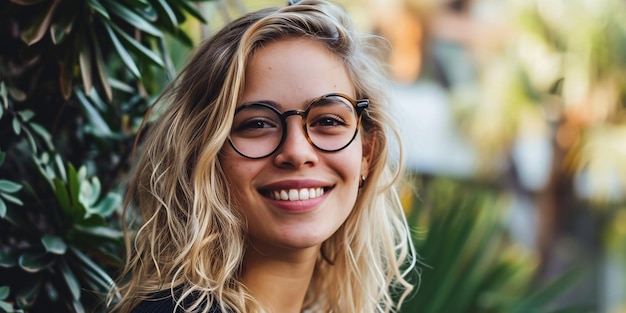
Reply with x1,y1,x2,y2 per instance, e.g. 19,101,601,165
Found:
220,38,369,252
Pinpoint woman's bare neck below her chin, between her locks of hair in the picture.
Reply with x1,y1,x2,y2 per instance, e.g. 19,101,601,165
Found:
242,239,319,313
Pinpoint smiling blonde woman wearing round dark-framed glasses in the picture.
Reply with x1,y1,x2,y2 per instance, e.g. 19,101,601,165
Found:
110,0,415,312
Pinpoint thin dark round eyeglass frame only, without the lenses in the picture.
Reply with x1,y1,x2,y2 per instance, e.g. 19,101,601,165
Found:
228,93,370,160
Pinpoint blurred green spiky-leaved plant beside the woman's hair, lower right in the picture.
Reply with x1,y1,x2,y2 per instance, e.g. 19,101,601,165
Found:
402,179,592,313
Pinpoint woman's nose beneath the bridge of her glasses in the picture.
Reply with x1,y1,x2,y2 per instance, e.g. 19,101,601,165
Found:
274,115,318,168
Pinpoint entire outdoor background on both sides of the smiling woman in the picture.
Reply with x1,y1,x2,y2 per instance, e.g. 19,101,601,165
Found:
0,0,626,313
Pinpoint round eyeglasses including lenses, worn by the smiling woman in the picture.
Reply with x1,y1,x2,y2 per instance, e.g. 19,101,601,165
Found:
228,93,369,159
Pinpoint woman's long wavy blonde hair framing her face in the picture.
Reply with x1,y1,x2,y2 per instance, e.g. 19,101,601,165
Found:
112,0,415,312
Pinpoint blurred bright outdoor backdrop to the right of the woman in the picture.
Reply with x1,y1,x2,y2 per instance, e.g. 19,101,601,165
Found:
206,0,626,312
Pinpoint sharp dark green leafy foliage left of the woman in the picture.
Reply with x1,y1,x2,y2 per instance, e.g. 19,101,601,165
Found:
0,0,205,312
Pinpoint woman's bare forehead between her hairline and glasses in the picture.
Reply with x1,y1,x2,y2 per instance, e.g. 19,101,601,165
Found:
238,38,355,105
